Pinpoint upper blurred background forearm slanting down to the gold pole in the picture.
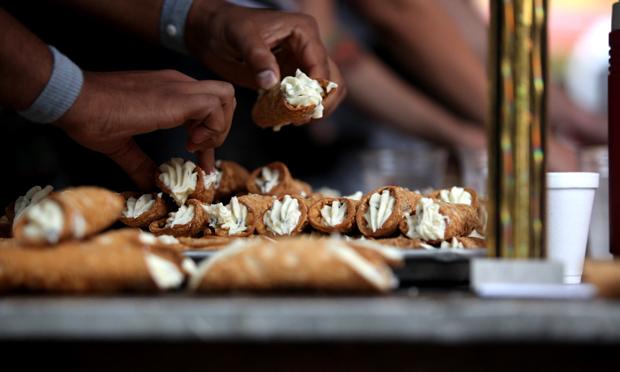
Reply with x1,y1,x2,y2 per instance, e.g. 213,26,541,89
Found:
360,0,487,123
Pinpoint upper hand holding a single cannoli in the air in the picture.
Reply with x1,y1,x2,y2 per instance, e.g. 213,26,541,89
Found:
186,0,346,114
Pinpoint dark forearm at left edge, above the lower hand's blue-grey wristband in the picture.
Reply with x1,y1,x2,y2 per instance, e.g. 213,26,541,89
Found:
0,8,53,110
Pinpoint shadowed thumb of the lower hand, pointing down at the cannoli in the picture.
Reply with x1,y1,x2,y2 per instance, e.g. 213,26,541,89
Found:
107,138,156,191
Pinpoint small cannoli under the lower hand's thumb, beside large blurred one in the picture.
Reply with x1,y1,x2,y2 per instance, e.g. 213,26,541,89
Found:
120,192,168,228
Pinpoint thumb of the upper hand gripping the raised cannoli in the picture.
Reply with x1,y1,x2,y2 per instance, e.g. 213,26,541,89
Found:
231,22,280,89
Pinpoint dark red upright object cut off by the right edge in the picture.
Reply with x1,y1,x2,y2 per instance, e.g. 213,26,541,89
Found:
608,25,620,256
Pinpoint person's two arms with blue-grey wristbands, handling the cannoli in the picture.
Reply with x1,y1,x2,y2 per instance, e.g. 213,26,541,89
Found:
0,0,345,188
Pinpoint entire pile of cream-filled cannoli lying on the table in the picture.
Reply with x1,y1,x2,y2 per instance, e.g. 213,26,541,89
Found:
0,158,485,293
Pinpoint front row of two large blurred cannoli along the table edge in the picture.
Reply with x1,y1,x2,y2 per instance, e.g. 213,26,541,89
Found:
0,229,402,293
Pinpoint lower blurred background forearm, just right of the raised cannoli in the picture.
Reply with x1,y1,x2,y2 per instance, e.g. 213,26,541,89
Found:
345,55,479,147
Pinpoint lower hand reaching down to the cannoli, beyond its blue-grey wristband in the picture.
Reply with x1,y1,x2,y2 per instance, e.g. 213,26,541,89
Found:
55,70,236,189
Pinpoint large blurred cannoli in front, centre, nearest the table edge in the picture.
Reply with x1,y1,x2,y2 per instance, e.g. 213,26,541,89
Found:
189,238,398,292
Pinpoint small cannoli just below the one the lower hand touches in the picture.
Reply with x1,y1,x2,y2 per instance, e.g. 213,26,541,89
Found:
149,199,207,237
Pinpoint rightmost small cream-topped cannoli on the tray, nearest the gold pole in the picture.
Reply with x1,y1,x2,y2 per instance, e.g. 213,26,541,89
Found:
400,198,480,244
